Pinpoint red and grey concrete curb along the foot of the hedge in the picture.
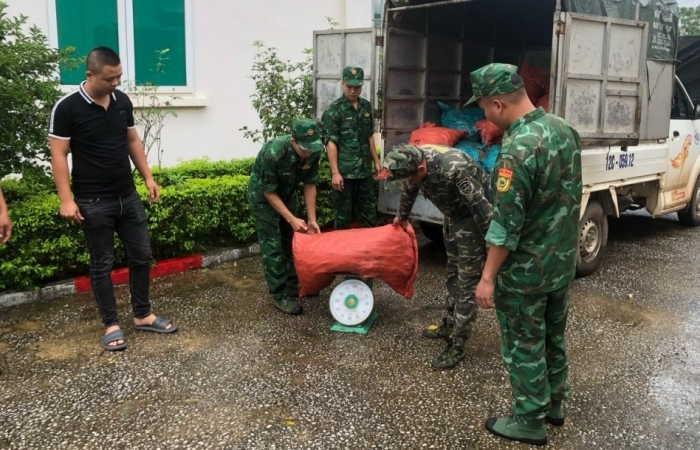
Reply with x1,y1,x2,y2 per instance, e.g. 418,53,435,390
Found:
0,244,260,307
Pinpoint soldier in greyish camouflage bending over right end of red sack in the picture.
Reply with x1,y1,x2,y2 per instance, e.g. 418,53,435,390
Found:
383,145,491,369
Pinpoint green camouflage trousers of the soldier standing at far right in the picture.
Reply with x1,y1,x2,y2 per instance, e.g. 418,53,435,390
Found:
494,285,569,419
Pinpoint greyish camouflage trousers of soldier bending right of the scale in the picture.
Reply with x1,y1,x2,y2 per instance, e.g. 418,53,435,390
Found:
442,216,486,345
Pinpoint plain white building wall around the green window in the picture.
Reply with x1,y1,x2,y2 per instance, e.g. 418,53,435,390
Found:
8,0,372,165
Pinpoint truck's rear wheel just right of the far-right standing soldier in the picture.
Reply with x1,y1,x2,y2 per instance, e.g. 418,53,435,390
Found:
576,200,608,277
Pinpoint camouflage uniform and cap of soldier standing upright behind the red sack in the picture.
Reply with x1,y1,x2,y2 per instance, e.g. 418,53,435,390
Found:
322,67,377,230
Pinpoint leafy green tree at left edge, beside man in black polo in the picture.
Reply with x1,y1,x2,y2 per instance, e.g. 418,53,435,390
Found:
0,1,75,178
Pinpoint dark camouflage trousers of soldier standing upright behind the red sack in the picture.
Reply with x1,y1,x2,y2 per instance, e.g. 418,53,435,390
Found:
332,177,377,230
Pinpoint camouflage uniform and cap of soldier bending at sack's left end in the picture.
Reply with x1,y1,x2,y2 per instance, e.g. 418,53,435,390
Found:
247,120,323,312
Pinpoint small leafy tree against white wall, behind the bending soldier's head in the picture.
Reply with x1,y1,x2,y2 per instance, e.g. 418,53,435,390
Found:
239,41,313,143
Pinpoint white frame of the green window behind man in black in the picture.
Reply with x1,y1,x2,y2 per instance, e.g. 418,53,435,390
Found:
46,0,195,94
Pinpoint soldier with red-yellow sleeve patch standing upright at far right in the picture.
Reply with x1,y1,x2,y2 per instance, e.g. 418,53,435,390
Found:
470,64,582,445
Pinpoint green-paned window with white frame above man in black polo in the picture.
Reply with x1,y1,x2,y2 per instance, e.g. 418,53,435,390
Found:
48,0,193,92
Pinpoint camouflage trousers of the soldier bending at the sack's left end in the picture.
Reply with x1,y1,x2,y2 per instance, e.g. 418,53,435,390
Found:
251,197,299,300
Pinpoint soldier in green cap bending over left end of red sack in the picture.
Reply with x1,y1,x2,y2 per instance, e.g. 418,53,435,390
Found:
247,119,323,315
